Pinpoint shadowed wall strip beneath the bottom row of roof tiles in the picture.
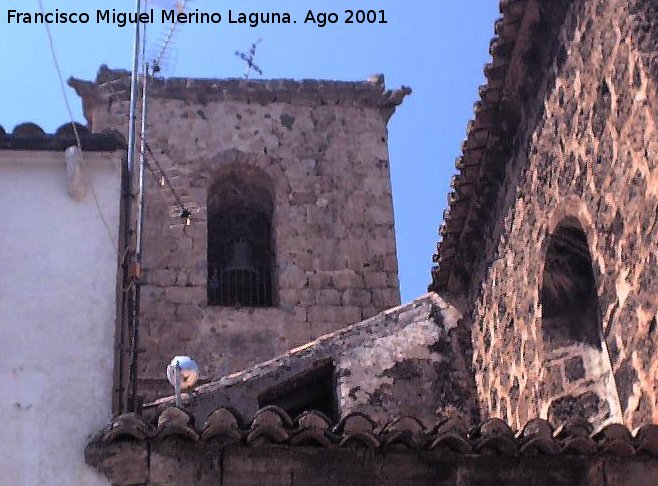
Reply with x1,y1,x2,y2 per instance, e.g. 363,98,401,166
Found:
91,439,658,486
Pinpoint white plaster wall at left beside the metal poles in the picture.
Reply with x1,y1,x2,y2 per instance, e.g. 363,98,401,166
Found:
0,151,121,486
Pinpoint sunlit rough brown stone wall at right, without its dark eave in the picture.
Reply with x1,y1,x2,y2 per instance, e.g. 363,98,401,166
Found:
470,0,658,426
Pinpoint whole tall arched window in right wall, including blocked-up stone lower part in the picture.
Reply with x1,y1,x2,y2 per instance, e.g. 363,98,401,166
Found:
541,217,621,425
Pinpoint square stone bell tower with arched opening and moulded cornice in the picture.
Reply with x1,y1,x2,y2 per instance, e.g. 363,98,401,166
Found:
70,67,410,400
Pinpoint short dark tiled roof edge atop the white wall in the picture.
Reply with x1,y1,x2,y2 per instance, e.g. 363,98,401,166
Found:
0,123,126,152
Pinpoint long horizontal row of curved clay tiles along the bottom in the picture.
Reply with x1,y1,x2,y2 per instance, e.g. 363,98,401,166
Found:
92,406,658,458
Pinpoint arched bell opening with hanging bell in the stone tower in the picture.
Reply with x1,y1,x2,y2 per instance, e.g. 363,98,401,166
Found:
207,171,274,307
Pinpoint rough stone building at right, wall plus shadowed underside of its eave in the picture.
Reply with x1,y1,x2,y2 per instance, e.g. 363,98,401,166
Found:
435,0,658,426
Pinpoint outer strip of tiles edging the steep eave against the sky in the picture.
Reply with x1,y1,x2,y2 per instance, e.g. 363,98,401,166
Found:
430,0,529,291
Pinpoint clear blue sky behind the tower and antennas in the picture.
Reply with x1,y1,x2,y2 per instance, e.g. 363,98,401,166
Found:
0,0,498,302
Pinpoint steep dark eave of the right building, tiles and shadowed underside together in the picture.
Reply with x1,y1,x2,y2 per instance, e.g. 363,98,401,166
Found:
429,0,571,291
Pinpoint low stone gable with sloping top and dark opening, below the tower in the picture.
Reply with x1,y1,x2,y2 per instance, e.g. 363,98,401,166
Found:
145,293,476,424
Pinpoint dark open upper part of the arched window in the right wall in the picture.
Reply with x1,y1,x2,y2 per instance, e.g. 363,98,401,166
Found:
541,217,602,351
